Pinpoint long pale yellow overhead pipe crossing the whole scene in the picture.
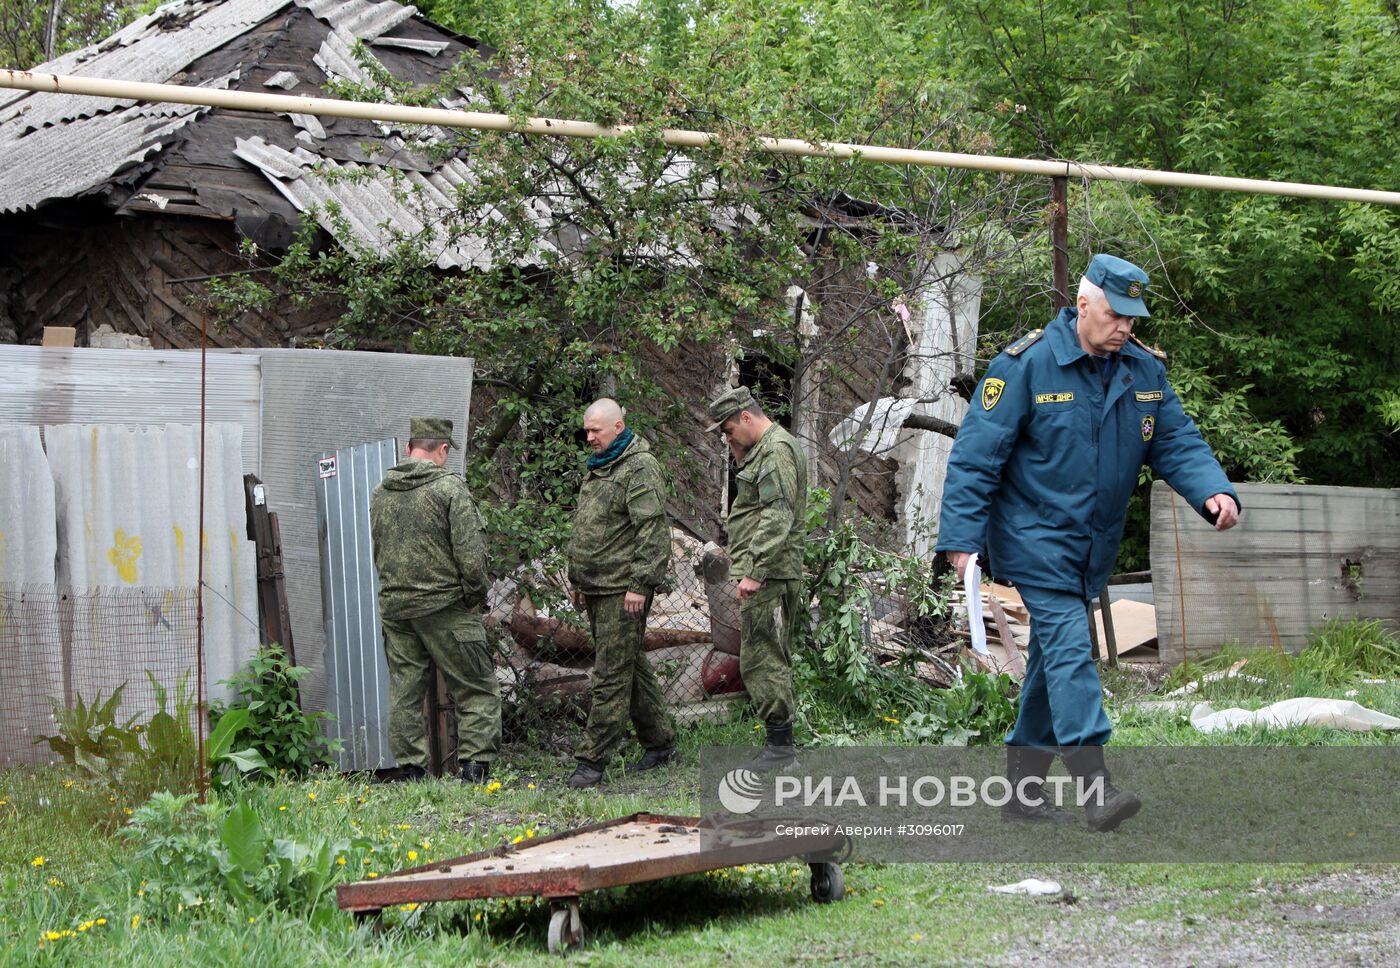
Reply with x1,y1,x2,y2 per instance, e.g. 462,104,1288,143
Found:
8,70,1400,206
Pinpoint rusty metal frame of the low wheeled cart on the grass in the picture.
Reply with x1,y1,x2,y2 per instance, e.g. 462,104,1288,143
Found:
336,813,846,913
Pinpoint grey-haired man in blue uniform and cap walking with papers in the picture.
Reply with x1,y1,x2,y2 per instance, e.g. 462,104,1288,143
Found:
937,255,1239,831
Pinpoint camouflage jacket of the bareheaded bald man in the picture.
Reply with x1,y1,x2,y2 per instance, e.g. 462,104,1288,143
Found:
568,437,671,595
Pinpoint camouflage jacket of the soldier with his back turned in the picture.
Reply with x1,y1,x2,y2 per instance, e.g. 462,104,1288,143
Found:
370,457,490,619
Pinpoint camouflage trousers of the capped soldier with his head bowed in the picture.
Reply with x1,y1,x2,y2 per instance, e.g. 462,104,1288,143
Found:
739,579,802,726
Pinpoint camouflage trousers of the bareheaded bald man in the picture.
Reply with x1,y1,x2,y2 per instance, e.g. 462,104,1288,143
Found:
574,595,676,766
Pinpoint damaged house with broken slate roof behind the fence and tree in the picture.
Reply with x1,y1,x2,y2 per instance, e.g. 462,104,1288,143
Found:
0,0,980,553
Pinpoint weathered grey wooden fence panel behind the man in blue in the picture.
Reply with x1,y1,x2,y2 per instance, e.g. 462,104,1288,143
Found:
1152,482,1400,663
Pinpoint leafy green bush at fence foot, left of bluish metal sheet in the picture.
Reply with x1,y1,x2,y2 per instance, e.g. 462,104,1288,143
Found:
209,644,339,775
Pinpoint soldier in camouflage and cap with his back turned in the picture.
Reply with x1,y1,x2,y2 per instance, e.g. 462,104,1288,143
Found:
370,417,501,783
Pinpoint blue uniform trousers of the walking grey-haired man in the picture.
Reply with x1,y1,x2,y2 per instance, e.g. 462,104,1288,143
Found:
1007,584,1113,748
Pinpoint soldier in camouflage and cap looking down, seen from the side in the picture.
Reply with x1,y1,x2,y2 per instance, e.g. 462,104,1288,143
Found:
708,387,806,770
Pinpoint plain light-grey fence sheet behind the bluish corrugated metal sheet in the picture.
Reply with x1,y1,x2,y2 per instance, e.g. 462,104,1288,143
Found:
248,350,472,710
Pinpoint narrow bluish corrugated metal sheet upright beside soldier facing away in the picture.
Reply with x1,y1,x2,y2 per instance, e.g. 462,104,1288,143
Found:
316,440,398,770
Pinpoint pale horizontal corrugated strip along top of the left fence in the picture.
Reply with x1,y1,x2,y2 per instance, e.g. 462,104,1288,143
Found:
0,345,262,473
